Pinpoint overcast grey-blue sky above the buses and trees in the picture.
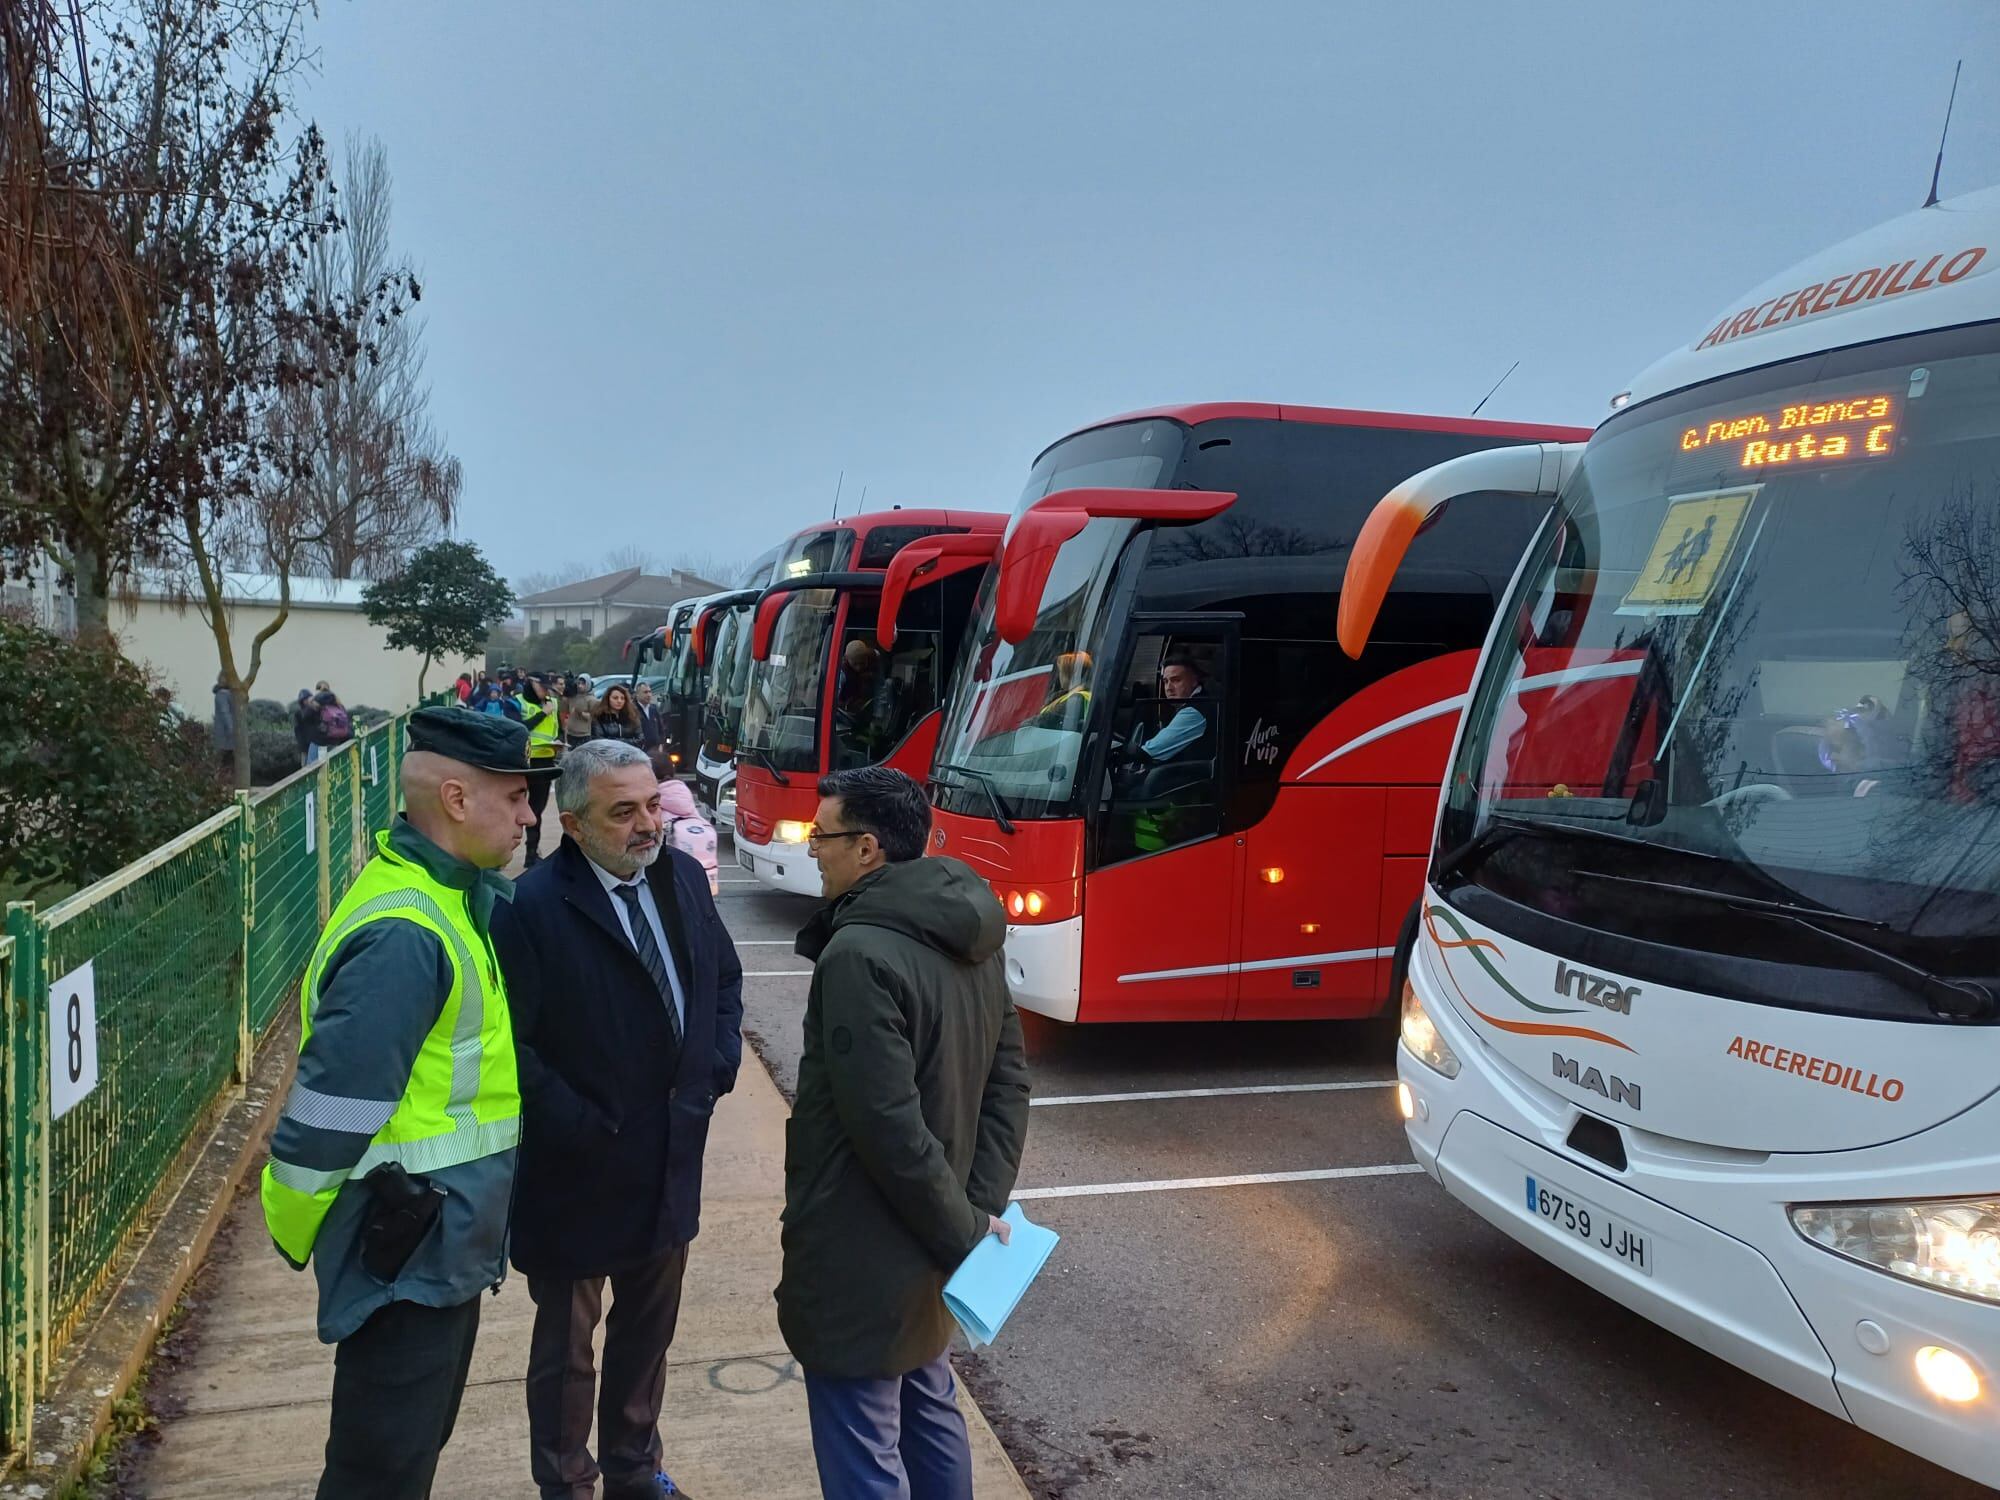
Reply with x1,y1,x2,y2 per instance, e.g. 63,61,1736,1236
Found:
300,0,2000,576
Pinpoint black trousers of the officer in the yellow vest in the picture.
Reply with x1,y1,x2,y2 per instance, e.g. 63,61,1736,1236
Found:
318,1298,480,1500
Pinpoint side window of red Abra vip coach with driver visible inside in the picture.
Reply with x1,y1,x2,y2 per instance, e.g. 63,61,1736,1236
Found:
1100,622,1234,864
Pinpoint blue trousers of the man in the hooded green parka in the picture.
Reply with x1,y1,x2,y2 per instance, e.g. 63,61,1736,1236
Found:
806,1354,972,1500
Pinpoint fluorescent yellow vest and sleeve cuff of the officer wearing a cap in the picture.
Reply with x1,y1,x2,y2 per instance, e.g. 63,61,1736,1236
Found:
262,832,520,1262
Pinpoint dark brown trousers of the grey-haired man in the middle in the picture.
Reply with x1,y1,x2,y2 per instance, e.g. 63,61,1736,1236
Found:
528,1244,688,1500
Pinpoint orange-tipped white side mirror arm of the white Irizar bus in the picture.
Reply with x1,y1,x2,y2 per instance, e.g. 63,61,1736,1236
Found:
1336,442,1584,660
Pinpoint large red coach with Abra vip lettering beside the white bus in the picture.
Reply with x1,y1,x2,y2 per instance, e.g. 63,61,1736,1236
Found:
930,404,1588,1022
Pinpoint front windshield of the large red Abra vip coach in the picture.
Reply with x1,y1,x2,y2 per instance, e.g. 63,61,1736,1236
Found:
934,420,1184,818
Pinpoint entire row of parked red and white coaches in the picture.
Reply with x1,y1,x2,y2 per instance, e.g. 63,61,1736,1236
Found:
624,190,2000,1484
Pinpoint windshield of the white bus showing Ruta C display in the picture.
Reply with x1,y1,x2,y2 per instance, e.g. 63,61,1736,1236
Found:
1432,324,2000,1014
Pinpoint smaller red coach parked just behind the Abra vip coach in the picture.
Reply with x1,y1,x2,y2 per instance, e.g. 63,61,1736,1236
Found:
736,510,1006,896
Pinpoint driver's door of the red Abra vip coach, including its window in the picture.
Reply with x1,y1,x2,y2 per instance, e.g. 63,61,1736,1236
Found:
1080,614,1244,1020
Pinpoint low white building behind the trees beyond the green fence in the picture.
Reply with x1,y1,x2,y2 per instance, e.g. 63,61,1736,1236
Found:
110,572,484,720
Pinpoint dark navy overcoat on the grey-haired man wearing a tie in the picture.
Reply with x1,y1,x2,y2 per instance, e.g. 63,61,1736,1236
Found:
492,838,744,1278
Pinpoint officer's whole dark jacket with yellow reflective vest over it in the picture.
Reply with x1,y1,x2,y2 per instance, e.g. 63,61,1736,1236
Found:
264,818,520,1344
